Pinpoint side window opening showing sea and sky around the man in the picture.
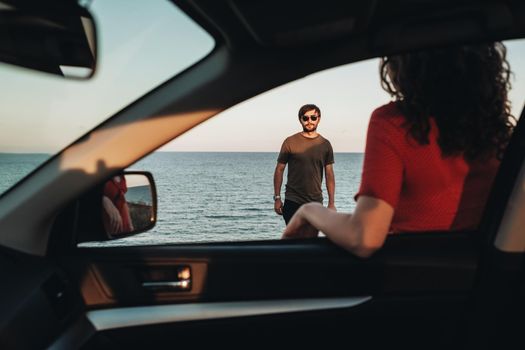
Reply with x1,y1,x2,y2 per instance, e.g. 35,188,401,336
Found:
82,40,525,245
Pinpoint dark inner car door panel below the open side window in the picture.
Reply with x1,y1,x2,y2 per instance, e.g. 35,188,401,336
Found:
63,232,478,346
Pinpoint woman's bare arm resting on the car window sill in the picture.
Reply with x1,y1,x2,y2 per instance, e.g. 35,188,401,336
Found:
283,196,394,257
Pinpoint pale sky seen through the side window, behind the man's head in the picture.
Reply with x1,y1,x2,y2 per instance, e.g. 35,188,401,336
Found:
162,40,525,152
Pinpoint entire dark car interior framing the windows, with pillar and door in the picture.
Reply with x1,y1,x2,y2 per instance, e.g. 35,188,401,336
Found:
0,0,525,349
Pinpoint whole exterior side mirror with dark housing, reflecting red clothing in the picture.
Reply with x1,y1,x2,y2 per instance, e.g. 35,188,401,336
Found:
77,171,157,243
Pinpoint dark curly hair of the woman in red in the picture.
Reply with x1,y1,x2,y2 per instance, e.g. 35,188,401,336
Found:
380,42,516,161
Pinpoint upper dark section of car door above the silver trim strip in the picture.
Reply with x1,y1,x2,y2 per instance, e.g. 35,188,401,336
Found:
73,232,477,307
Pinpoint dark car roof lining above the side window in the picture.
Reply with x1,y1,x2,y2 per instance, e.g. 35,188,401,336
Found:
174,0,525,54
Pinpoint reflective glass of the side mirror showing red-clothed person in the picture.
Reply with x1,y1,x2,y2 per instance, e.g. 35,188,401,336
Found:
101,173,156,238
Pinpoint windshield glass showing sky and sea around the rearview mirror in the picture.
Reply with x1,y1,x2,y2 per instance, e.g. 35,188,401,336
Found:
0,0,214,194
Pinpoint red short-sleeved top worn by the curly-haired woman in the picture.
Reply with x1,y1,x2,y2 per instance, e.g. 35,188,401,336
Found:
356,102,499,232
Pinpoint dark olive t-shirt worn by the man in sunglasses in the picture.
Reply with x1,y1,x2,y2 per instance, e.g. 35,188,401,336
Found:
277,133,334,204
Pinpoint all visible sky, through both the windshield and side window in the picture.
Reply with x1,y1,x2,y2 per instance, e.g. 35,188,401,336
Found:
0,0,525,153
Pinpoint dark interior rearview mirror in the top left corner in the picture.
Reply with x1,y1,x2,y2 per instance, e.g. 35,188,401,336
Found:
0,0,97,79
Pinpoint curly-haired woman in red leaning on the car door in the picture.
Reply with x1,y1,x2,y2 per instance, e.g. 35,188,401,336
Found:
283,43,515,257
